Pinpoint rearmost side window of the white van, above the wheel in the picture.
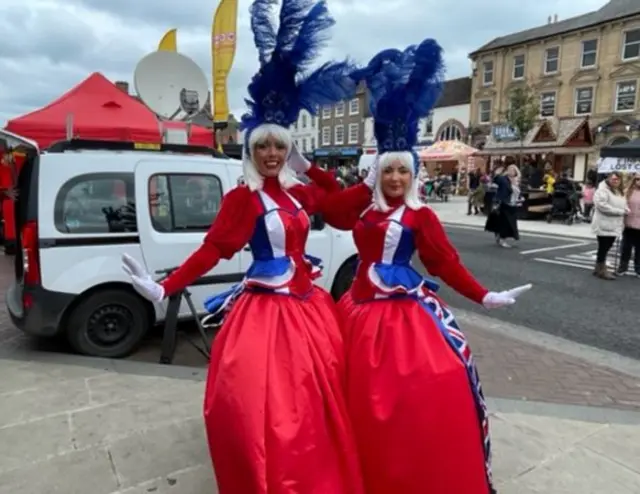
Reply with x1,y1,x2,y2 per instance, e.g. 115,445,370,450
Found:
53,173,138,233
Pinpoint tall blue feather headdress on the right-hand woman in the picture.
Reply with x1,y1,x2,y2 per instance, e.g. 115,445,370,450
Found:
352,39,444,174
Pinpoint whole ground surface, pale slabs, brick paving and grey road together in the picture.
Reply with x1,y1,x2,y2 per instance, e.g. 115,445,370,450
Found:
0,200,640,494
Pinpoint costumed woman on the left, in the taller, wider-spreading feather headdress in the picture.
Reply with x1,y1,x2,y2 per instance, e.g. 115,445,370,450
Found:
124,0,363,494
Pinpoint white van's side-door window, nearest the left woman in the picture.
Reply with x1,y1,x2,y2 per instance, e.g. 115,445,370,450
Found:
149,173,223,233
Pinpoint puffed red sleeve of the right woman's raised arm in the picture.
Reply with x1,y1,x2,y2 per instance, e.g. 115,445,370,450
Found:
319,183,372,230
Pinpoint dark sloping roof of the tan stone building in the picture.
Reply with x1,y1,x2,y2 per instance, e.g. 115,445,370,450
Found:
469,0,640,57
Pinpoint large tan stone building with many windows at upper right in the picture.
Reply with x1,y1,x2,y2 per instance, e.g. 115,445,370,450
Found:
470,0,640,179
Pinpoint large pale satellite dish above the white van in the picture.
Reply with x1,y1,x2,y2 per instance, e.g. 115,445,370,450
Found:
133,51,209,121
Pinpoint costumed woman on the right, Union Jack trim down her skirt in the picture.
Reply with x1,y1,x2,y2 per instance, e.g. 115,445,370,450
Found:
322,40,530,494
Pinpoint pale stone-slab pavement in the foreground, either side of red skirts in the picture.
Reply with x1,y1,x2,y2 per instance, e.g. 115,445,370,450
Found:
0,352,640,494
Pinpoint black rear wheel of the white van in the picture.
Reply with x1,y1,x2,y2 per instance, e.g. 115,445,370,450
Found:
67,290,149,358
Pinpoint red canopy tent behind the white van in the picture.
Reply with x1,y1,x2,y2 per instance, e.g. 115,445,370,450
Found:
6,72,214,149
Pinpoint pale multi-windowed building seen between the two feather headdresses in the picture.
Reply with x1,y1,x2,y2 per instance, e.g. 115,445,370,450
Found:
314,84,368,165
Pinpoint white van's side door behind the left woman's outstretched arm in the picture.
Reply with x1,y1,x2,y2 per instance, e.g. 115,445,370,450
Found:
135,157,243,316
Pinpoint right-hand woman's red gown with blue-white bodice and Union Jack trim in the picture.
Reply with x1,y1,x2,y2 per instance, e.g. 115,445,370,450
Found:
322,185,495,494
